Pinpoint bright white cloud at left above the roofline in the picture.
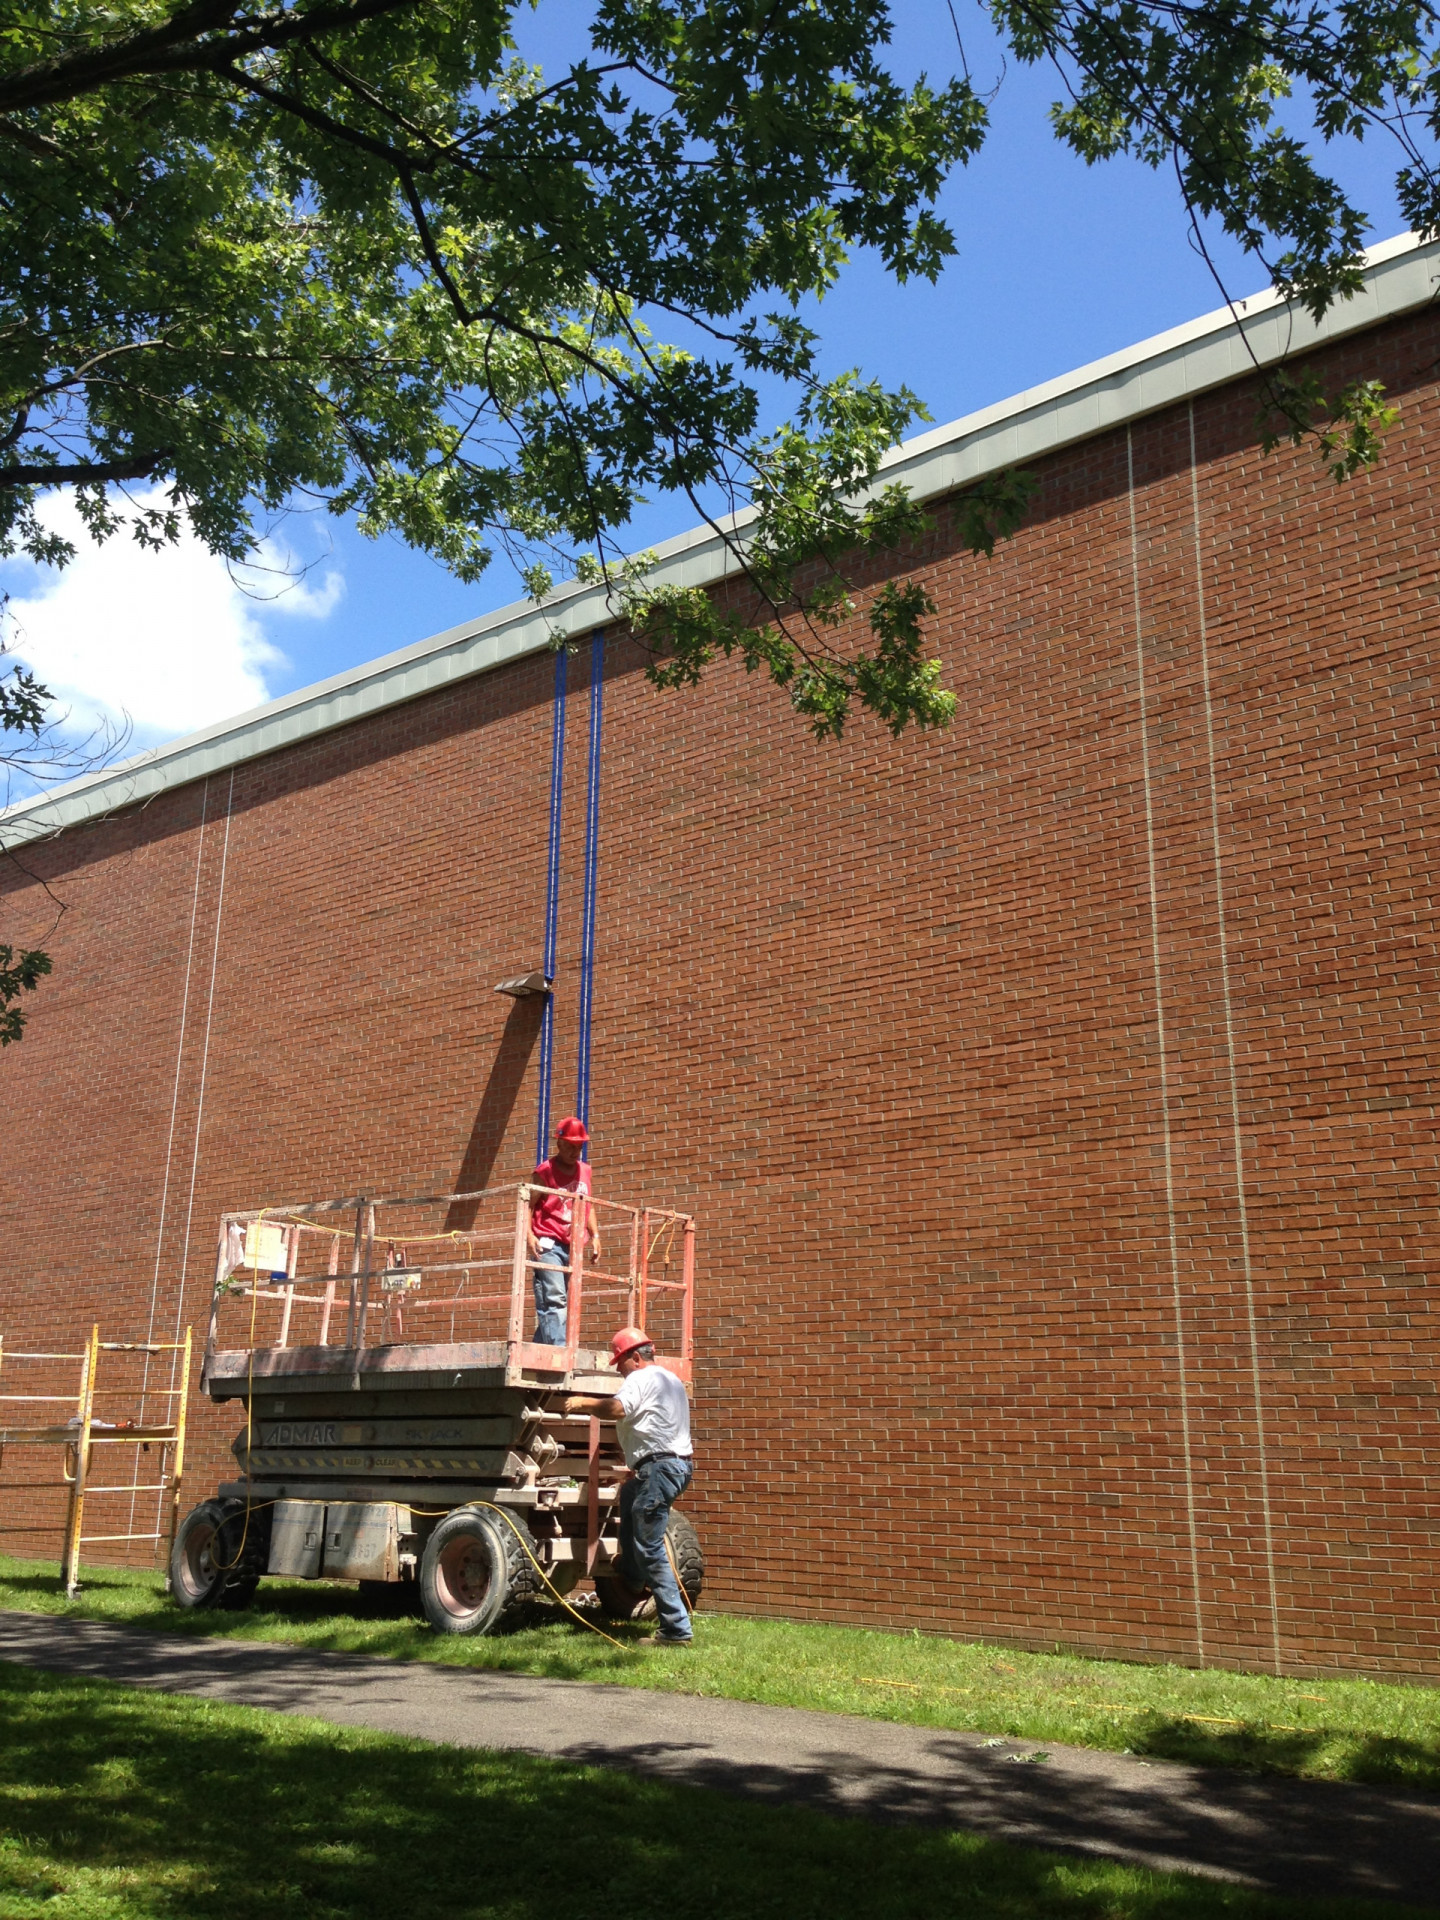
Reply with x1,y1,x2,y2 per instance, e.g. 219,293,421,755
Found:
0,493,344,747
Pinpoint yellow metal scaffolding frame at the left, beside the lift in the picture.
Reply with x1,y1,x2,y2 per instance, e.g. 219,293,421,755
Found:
0,1325,190,1597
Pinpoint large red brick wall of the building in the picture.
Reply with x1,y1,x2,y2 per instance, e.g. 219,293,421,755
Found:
0,303,1440,1676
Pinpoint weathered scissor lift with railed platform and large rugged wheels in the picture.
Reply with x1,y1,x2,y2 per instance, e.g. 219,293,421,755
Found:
171,1185,703,1632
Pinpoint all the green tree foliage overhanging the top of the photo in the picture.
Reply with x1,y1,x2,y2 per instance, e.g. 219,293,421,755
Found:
0,0,1440,764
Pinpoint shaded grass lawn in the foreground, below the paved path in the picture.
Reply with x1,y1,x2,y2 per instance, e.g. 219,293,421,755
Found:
0,1665,1417,1920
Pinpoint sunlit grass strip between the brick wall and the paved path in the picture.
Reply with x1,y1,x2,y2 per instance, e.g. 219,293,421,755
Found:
0,1559,1440,1791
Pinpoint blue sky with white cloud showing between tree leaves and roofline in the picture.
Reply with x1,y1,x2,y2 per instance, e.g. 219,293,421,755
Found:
0,0,1404,764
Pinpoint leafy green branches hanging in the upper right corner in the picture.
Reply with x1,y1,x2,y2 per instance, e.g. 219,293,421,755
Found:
989,0,1440,480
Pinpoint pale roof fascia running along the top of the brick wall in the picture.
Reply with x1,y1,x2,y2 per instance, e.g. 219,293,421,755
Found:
0,234,1440,847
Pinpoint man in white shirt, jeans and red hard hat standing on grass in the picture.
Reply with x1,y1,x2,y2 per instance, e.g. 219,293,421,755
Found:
563,1327,695,1647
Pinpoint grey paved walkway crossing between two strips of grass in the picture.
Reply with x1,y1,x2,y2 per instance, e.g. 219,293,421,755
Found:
0,1611,1440,1907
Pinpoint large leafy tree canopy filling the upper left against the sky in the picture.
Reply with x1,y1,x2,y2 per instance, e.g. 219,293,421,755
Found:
0,0,985,741
